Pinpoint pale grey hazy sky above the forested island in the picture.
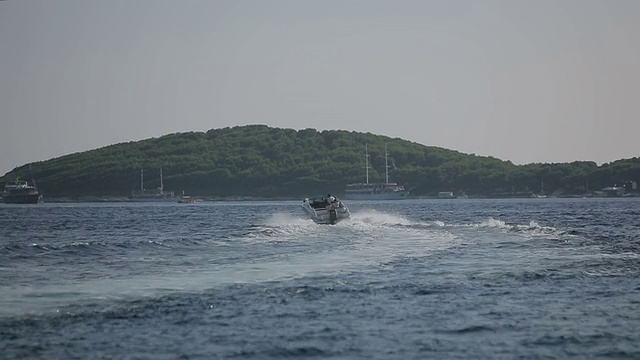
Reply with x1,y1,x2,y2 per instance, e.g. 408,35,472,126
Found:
0,0,640,174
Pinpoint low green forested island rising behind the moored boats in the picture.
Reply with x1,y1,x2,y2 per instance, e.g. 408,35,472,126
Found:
0,125,640,199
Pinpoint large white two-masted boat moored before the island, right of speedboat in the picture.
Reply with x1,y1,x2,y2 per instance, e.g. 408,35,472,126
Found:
344,145,411,200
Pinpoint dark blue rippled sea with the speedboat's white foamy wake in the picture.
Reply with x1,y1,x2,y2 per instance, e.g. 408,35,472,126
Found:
0,199,640,359
